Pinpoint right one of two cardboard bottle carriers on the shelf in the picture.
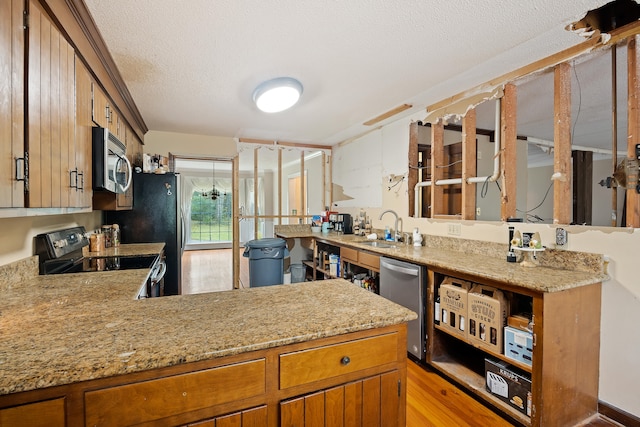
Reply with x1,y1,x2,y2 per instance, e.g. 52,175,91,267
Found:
467,285,509,354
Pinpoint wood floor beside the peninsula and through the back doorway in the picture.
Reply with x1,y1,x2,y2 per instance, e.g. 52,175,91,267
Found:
182,249,620,427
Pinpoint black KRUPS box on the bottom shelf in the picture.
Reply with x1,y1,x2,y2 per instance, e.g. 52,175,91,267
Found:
484,358,531,416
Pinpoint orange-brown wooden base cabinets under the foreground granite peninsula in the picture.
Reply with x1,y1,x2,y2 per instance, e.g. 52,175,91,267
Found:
0,324,407,427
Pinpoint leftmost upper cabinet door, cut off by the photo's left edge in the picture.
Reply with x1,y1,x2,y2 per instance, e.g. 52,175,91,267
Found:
0,0,25,208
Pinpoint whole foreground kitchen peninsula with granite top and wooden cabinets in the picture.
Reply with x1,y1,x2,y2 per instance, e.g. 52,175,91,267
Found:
0,257,415,426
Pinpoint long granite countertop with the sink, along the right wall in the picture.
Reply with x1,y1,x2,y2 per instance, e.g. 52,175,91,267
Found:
276,225,609,292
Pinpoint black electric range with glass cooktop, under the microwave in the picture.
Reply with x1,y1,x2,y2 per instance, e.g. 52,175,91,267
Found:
35,227,166,298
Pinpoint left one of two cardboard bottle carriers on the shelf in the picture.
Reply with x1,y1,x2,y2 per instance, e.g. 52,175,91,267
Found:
438,277,471,339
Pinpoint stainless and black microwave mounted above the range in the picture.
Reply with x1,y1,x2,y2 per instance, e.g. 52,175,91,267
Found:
93,127,132,193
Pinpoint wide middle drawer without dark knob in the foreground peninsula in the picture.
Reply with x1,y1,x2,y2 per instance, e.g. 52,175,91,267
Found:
85,359,266,426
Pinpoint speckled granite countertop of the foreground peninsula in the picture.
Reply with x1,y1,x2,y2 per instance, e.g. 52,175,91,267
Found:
0,260,416,394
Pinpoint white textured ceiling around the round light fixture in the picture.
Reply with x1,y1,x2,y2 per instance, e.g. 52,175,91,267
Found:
85,0,608,145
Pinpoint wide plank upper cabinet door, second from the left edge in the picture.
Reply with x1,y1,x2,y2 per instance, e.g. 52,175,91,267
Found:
27,0,75,208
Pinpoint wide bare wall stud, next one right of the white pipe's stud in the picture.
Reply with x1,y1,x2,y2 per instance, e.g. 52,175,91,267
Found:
500,83,518,221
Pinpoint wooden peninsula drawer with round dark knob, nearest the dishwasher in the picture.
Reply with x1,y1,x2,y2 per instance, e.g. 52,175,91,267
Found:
280,332,399,389
